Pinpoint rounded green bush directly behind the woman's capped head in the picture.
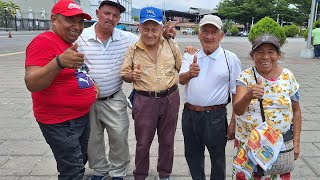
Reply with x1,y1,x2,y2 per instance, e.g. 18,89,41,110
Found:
248,17,286,46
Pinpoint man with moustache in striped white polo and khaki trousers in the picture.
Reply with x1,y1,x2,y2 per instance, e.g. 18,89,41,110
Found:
77,0,179,180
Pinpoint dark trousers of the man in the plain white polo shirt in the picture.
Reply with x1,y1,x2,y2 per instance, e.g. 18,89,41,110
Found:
182,108,228,180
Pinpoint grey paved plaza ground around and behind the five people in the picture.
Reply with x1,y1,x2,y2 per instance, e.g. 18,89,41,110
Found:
0,33,320,180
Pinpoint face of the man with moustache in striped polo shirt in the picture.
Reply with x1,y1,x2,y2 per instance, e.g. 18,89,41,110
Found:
96,5,121,32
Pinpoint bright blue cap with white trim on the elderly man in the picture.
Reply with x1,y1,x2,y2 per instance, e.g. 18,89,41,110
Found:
140,6,163,25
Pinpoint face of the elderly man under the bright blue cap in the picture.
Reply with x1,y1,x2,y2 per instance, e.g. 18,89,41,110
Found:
138,20,163,48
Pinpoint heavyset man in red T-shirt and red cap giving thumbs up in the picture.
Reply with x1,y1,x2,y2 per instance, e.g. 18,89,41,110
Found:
25,0,98,180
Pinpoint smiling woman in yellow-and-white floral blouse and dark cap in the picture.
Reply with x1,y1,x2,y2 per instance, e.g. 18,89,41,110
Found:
232,34,301,180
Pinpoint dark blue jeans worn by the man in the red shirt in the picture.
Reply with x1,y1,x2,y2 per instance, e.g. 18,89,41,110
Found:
38,114,90,180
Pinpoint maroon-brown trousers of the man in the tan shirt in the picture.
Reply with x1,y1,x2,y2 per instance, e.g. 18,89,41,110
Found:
133,89,180,180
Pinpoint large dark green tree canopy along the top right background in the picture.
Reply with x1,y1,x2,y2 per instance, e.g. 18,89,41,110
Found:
217,0,311,25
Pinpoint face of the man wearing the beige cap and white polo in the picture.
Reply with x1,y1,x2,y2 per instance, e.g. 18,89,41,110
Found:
198,24,224,55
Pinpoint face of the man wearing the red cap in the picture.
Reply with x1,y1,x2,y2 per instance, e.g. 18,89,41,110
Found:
51,14,84,44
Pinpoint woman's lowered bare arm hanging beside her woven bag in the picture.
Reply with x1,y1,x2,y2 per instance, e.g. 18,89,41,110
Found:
292,101,302,160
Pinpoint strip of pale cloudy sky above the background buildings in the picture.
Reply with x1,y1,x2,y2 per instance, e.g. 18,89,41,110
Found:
132,0,221,11
